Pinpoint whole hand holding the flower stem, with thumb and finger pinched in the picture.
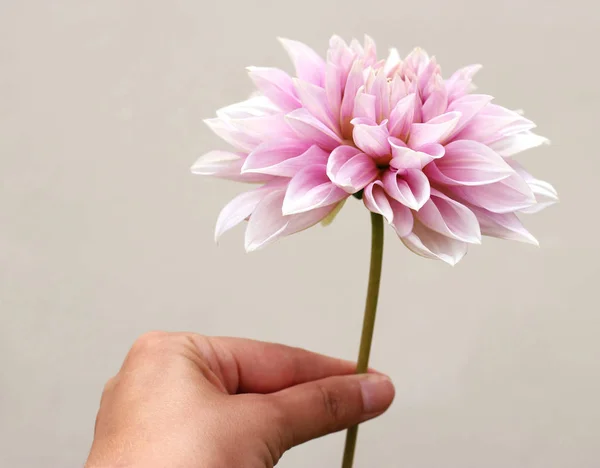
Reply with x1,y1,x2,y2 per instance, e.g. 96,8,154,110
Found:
85,332,394,468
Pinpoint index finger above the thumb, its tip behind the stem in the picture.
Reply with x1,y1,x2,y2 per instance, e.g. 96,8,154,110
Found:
203,337,356,393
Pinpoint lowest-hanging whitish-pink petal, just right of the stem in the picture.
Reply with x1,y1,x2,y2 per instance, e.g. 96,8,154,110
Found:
401,222,468,266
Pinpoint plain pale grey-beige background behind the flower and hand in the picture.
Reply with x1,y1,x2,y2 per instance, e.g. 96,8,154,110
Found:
0,0,600,468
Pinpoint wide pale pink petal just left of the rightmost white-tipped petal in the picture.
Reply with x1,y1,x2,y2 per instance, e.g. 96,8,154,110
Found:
448,173,536,213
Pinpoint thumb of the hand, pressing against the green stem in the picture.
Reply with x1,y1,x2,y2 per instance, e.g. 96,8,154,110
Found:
267,374,395,451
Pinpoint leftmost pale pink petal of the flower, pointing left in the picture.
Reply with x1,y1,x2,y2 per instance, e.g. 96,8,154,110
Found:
191,151,273,183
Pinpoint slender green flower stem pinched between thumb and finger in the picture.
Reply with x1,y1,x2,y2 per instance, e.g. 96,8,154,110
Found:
342,213,383,468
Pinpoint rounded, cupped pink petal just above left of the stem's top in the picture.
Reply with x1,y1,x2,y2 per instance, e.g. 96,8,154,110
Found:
327,146,379,193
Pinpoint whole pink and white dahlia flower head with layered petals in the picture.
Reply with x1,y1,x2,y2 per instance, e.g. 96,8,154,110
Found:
192,36,557,264
